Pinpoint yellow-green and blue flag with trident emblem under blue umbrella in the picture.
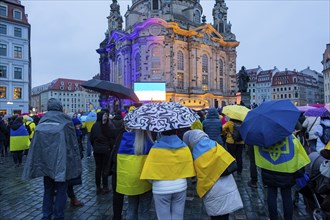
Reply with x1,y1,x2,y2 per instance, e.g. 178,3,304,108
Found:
254,135,311,173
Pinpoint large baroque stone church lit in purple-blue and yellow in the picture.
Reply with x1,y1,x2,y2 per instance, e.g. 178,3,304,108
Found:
97,0,239,109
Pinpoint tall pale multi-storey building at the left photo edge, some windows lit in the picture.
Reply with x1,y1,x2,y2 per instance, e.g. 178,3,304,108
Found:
0,0,31,114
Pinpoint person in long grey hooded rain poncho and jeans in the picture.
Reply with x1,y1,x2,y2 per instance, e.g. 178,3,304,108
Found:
22,98,82,219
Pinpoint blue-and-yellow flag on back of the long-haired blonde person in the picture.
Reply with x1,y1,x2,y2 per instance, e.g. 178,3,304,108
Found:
116,132,152,196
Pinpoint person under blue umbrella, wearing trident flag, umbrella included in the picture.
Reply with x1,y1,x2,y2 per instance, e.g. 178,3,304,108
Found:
240,100,310,220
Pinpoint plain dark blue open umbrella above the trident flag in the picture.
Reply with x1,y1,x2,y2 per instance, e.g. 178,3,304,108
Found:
240,100,300,147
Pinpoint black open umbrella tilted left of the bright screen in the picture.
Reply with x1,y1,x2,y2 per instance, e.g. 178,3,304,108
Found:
81,79,139,102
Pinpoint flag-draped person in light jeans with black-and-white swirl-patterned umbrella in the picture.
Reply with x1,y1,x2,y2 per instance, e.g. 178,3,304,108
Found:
124,102,199,220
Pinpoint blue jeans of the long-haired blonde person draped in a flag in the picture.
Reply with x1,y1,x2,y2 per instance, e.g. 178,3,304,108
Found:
126,190,152,220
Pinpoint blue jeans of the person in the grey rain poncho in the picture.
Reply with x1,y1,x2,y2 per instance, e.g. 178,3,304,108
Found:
42,176,68,220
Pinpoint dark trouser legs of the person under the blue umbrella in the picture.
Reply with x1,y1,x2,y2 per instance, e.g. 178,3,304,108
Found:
267,186,293,220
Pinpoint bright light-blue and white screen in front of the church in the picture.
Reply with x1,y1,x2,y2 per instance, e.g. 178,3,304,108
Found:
134,82,166,101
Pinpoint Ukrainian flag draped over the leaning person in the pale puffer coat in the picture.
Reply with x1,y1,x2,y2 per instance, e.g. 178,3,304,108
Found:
193,139,235,198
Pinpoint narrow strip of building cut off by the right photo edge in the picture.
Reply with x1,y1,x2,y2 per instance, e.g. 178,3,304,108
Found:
322,44,330,103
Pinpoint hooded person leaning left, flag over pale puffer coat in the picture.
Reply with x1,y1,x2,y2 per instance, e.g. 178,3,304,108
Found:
183,130,243,220
